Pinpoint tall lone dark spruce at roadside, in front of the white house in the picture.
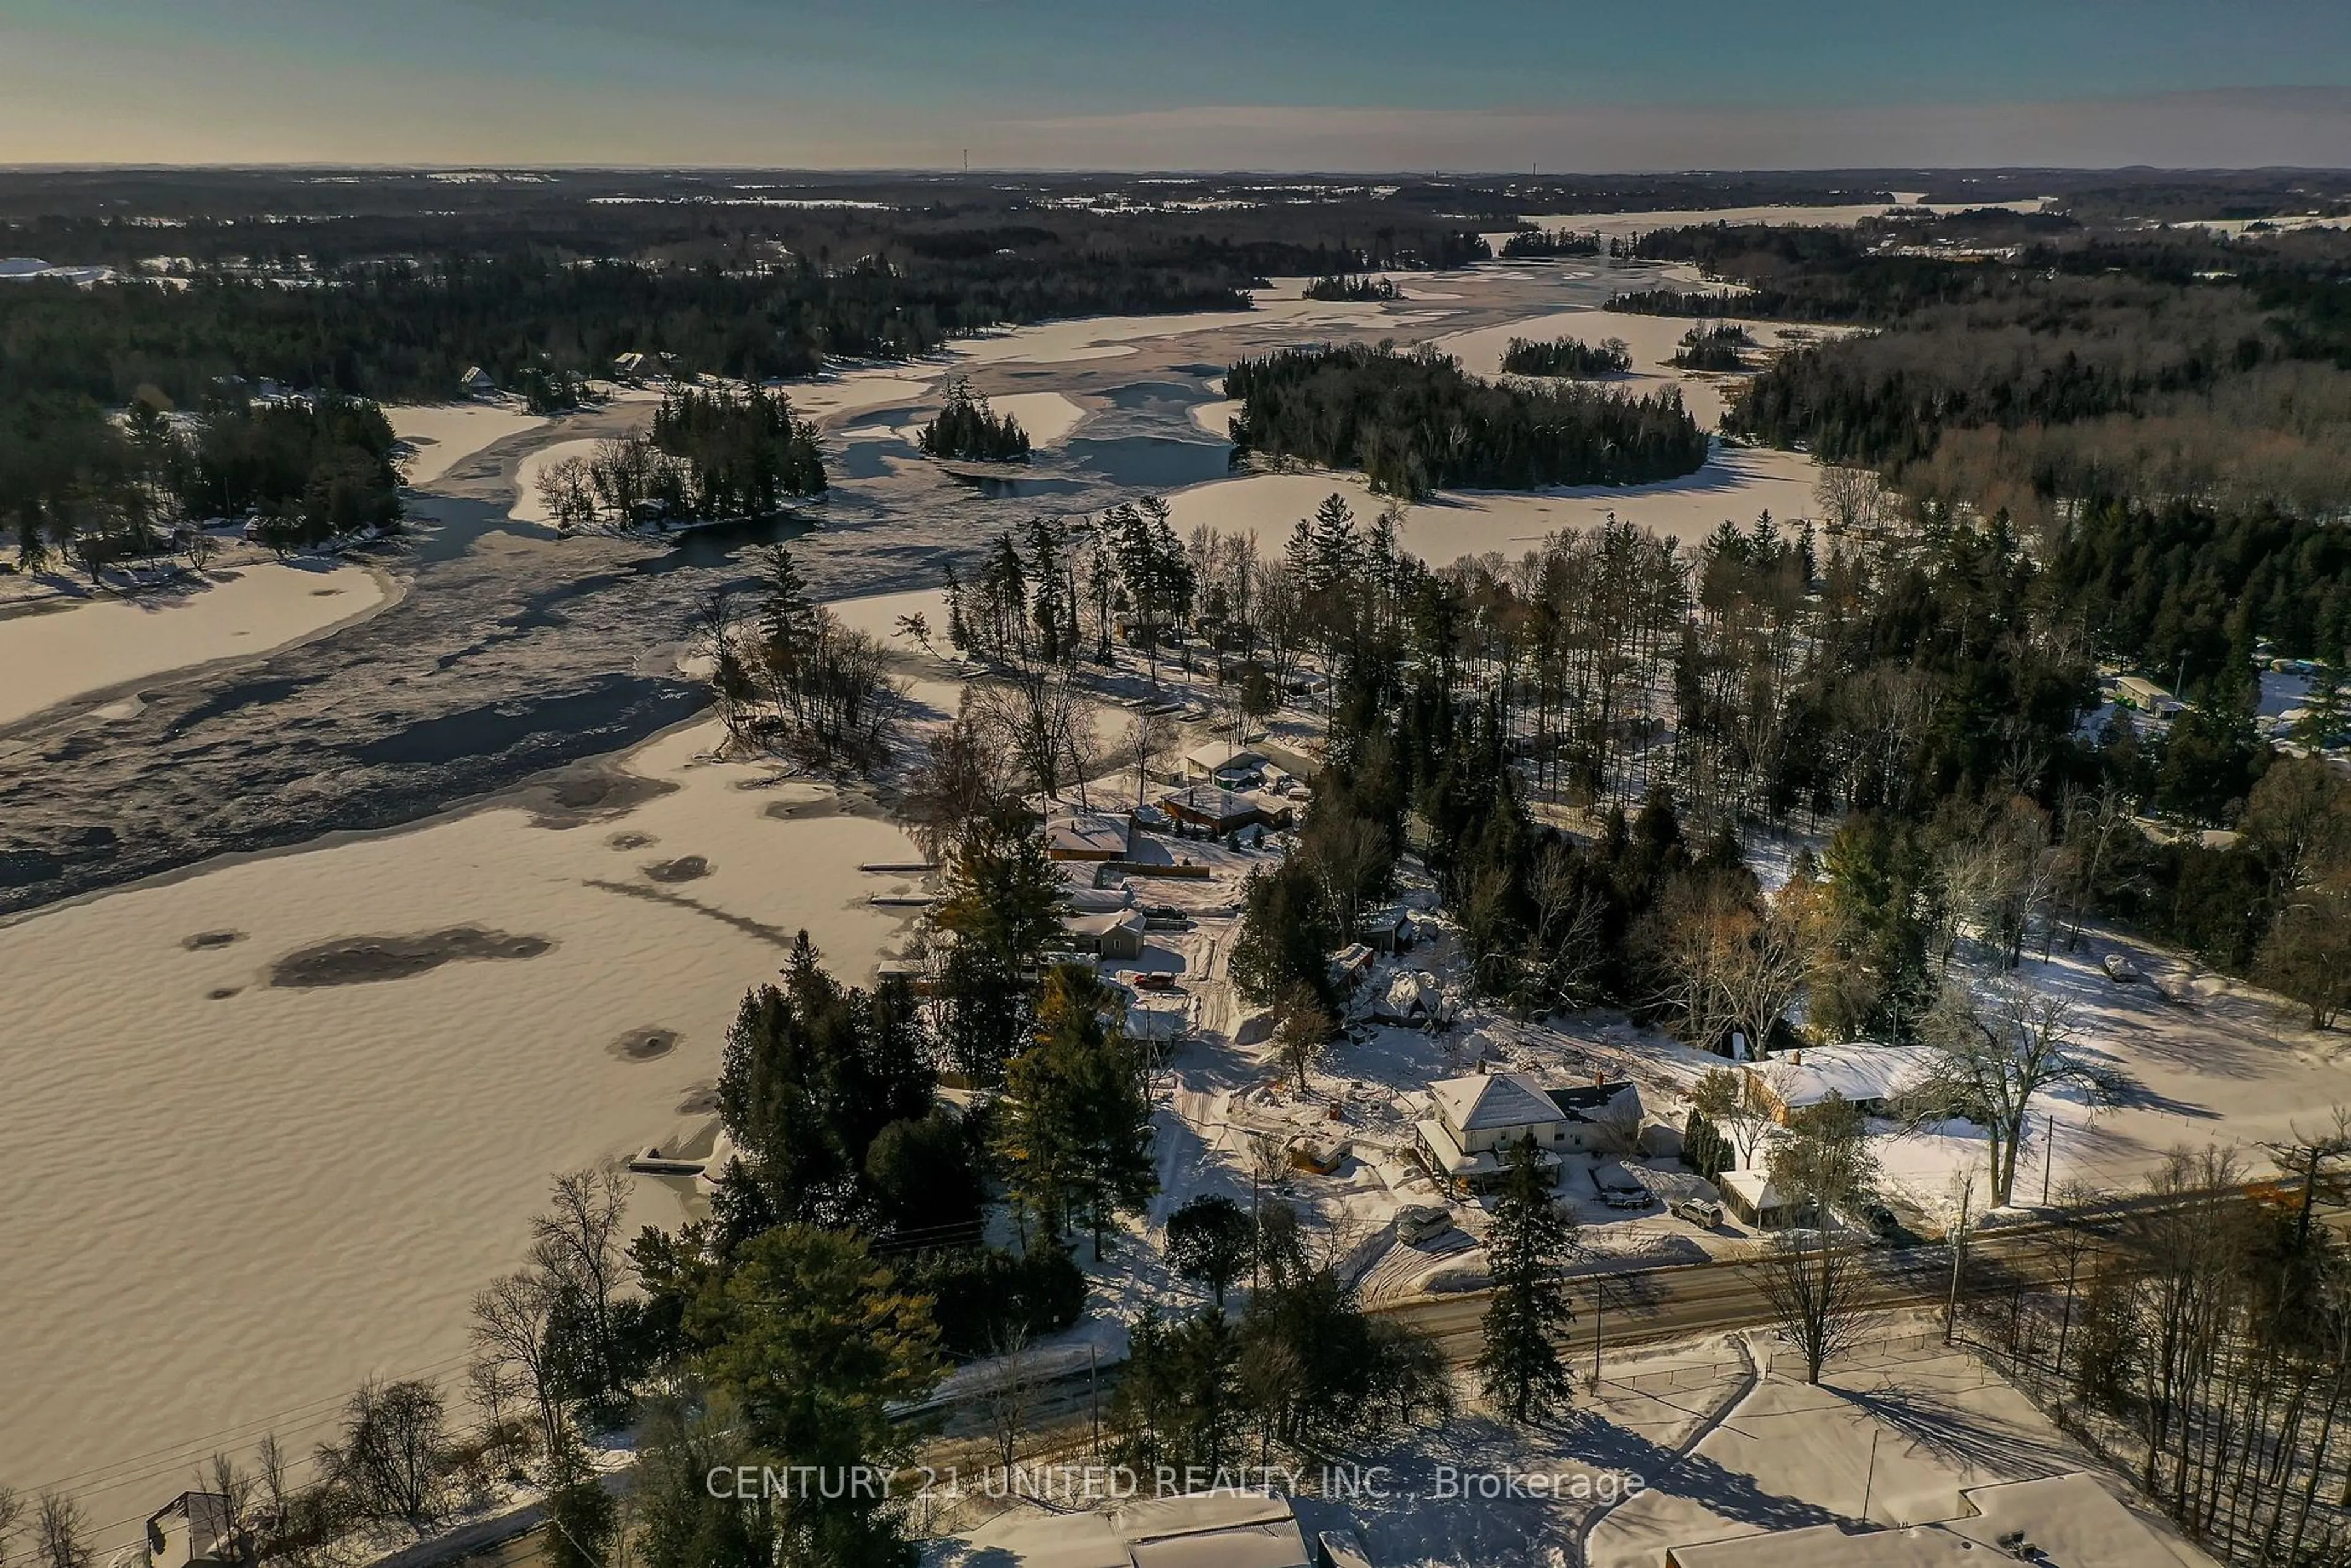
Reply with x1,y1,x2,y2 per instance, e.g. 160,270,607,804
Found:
1477,1138,1575,1422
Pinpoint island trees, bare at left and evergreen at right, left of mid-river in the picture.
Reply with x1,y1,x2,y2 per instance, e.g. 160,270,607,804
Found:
538,386,825,529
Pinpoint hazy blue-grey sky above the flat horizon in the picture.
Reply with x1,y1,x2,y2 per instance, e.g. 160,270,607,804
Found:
0,0,2351,169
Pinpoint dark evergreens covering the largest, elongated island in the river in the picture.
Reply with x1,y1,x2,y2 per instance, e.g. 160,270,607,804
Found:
1225,345,1707,498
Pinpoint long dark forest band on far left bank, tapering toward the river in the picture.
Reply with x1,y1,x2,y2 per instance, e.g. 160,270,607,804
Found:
0,254,1251,404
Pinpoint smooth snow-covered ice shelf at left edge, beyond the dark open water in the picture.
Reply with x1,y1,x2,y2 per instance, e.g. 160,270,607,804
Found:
0,557,395,724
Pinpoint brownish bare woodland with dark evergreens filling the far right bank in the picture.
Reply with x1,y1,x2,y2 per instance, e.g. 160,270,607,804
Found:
1648,228,2351,703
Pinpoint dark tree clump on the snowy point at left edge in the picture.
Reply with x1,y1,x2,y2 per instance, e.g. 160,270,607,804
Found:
0,397,402,574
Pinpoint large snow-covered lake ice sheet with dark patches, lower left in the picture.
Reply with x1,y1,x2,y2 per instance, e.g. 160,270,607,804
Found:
0,662,912,1523
